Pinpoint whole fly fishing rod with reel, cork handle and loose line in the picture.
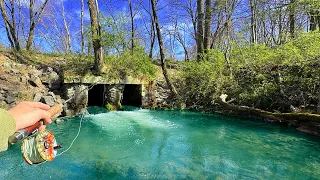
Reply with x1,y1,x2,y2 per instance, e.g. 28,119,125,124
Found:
8,82,99,165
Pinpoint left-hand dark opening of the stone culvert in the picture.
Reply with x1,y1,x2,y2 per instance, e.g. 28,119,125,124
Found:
88,84,105,107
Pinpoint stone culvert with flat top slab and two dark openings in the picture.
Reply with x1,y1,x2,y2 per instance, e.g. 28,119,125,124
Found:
63,76,156,116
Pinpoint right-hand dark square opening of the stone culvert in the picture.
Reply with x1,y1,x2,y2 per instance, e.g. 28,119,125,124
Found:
121,84,141,107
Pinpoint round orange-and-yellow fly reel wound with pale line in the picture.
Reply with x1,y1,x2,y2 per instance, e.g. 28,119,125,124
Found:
21,129,61,165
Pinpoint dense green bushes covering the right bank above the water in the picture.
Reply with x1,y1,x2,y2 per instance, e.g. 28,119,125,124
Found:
178,32,320,112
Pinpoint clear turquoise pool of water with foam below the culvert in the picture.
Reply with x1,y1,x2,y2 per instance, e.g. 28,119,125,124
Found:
0,109,320,180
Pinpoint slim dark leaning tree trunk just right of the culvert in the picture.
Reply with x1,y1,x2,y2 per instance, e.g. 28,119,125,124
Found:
151,0,178,97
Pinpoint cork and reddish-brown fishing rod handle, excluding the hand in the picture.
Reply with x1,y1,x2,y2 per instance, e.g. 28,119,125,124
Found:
8,104,63,144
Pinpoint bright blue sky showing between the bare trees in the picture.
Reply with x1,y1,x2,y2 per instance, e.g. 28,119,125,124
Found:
0,0,182,56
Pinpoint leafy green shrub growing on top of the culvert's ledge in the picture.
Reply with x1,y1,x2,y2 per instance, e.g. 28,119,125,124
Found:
106,47,155,78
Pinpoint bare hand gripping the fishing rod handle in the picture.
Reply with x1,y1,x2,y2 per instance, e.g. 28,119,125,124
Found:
8,101,52,130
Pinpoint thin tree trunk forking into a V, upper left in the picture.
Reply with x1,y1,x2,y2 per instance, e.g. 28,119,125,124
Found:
26,0,48,51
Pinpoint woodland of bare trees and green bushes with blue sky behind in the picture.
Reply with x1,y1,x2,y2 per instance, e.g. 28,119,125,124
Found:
0,0,320,113
